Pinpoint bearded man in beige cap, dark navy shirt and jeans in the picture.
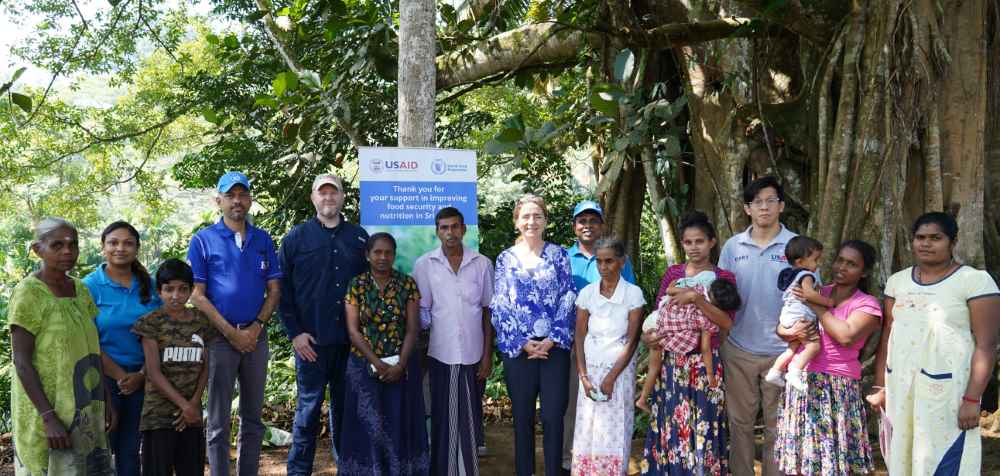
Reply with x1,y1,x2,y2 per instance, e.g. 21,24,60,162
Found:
279,174,368,476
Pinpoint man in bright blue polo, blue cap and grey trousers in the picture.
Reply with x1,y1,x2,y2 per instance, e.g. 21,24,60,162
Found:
188,172,282,476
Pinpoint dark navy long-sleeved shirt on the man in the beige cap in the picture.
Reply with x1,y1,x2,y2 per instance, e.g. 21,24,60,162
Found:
279,216,368,345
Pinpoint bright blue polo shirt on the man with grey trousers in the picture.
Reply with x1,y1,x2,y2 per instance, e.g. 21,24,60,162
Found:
188,219,282,324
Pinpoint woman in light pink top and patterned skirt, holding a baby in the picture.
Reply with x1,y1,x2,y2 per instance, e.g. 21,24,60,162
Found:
774,240,882,475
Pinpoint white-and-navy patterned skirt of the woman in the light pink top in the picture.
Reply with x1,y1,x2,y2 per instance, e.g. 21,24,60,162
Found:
774,372,874,475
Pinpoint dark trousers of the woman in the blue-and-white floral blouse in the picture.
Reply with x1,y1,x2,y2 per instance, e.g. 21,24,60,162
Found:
503,347,570,476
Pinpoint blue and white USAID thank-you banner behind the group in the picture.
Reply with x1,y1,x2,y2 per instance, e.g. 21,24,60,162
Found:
358,147,479,273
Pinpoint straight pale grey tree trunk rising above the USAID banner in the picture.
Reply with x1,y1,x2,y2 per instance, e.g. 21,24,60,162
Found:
398,0,436,147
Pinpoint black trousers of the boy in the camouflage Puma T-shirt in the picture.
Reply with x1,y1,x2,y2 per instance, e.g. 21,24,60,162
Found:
142,428,205,476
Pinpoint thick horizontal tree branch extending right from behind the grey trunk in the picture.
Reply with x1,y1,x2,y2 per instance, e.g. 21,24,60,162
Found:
438,16,767,91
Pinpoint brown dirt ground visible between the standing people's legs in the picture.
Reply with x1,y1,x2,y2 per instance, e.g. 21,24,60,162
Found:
0,423,1000,476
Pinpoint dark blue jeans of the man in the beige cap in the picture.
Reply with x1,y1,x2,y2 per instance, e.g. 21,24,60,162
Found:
288,344,351,476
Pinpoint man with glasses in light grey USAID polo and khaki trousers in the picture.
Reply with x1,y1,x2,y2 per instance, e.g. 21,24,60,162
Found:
719,177,796,476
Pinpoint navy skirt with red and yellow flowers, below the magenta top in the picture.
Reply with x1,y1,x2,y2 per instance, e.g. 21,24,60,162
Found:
639,349,729,475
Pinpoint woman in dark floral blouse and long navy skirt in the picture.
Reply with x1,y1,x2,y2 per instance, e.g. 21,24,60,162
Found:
337,233,430,476
